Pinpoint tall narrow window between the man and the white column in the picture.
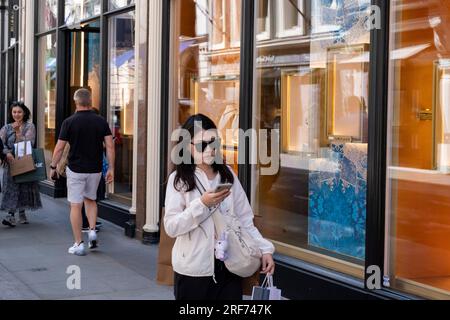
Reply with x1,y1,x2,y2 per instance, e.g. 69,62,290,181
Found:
108,11,135,205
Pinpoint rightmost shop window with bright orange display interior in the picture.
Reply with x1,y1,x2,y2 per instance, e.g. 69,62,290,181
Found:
386,0,450,299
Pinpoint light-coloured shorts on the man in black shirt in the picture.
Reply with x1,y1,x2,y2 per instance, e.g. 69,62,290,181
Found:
66,167,102,204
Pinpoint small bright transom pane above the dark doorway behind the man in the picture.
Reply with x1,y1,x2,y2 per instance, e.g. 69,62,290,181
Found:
64,0,102,25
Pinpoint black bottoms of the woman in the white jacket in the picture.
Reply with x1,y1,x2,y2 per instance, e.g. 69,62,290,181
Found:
174,260,243,301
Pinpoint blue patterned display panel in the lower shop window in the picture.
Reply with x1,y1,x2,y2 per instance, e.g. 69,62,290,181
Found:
308,143,367,260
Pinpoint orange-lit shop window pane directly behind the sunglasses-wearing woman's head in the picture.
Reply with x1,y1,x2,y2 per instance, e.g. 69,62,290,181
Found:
171,0,241,171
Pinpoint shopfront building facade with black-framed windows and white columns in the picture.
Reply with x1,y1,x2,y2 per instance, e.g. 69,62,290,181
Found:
0,0,450,299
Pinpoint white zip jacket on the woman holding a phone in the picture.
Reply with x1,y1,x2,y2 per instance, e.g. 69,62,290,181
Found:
164,168,275,277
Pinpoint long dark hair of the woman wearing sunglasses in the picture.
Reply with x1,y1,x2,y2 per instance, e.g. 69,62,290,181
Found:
174,114,234,192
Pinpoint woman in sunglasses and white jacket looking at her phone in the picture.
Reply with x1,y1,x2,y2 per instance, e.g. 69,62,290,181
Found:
164,114,275,300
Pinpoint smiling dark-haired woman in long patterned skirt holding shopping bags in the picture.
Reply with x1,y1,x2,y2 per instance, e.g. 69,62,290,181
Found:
0,102,42,228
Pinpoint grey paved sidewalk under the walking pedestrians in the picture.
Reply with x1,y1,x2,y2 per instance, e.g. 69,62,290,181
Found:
0,195,173,300
